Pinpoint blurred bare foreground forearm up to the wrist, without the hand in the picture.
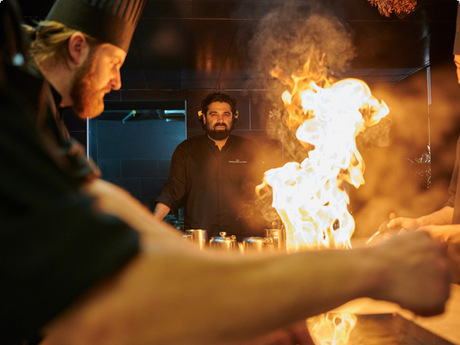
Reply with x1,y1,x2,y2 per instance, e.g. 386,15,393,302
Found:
41,244,378,345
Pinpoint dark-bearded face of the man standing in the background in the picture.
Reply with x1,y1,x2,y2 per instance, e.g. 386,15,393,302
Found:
203,102,233,140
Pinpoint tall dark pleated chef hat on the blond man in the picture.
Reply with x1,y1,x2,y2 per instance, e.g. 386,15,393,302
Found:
46,0,146,52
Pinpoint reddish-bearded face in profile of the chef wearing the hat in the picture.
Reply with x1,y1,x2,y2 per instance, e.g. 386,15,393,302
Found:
70,43,126,119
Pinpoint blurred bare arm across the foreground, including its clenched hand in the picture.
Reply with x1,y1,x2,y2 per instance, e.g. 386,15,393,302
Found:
39,223,449,345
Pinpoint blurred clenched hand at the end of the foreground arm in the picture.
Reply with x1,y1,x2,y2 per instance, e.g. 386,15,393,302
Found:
371,231,450,316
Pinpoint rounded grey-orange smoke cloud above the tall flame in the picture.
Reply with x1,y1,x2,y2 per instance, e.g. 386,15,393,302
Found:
247,0,355,110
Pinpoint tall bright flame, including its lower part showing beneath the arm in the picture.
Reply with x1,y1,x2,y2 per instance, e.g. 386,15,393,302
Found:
264,63,389,345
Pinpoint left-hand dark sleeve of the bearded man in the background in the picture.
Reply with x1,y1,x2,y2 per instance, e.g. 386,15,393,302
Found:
156,143,187,210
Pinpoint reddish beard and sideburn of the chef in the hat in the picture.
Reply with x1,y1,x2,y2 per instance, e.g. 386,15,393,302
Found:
70,52,104,119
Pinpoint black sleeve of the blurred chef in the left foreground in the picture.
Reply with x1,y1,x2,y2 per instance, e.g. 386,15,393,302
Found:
0,93,139,344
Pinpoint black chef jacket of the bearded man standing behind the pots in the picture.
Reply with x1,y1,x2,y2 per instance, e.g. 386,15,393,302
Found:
157,135,263,239
